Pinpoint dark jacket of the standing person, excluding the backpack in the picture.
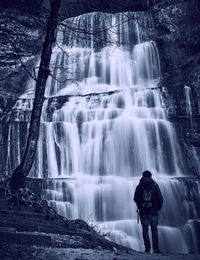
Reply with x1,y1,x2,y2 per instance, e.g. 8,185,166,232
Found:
134,177,163,215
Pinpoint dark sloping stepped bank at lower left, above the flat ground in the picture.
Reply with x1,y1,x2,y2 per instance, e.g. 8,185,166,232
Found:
0,188,126,250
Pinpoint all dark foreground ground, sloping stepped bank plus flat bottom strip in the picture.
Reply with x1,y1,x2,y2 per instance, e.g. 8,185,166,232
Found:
0,187,200,260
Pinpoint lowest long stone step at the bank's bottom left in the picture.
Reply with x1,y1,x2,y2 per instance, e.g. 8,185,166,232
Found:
0,231,52,246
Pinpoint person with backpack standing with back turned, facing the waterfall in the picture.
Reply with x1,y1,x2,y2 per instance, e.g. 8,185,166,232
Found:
134,170,163,254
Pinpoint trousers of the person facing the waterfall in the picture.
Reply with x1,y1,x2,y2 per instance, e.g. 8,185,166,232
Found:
140,213,159,251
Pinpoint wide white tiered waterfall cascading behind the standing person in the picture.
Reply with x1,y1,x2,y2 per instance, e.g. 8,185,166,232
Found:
7,13,200,253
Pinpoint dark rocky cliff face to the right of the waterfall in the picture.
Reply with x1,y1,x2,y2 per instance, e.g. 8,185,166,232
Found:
152,1,200,172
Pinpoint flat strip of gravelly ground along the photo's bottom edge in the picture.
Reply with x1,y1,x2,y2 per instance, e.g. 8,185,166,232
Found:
0,244,200,260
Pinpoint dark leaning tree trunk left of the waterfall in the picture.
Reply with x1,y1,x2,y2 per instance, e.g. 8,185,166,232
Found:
9,0,61,189
